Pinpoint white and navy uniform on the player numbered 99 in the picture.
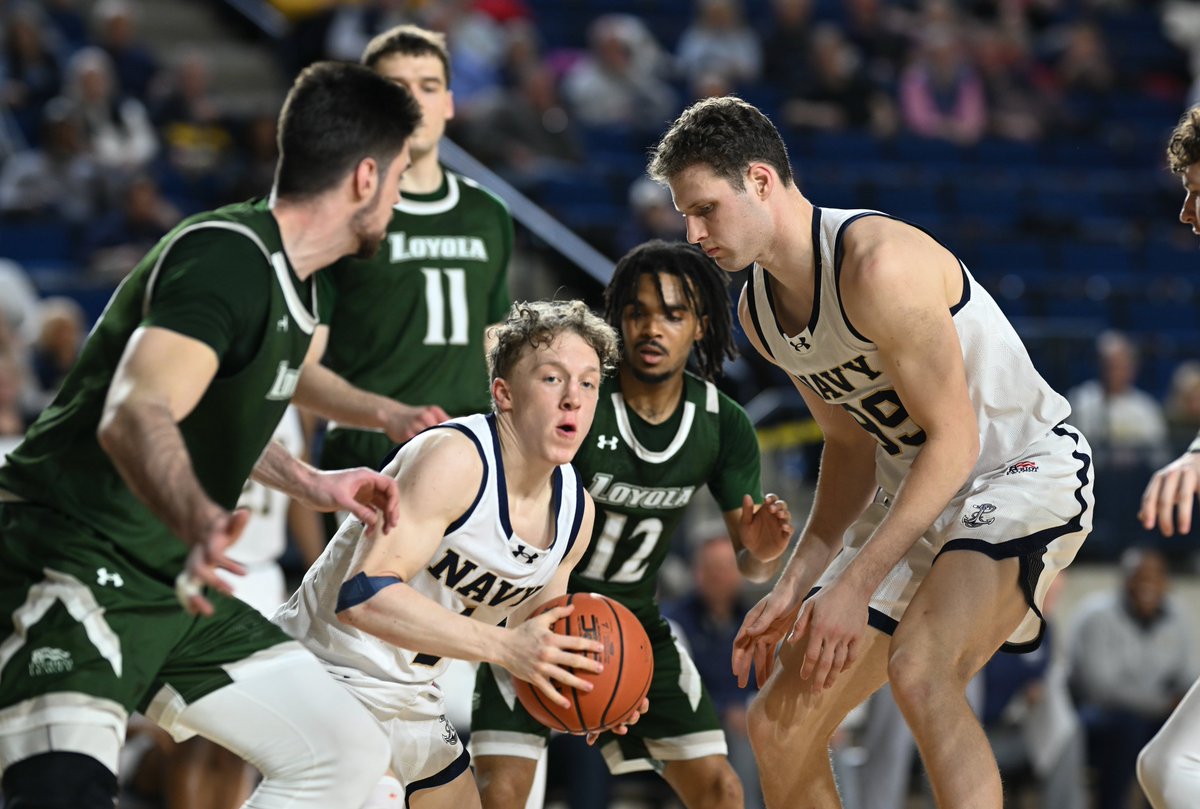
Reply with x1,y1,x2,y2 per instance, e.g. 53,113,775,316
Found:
746,208,1094,651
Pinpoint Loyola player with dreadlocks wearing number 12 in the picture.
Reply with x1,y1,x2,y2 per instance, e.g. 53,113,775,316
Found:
472,241,792,809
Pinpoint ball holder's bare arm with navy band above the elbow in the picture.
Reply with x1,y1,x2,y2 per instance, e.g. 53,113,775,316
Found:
337,430,600,702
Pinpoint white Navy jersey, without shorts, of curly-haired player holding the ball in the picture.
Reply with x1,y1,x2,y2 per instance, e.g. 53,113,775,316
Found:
274,415,586,701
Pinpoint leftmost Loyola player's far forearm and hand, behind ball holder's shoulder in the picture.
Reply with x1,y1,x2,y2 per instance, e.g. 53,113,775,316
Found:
250,441,400,531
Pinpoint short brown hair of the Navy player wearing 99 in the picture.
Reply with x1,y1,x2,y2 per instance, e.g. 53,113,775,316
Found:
647,96,792,191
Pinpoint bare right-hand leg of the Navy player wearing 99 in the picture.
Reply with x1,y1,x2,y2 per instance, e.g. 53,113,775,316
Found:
888,551,1028,809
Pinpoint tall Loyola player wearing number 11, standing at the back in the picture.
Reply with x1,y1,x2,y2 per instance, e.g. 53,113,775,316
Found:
320,25,512,492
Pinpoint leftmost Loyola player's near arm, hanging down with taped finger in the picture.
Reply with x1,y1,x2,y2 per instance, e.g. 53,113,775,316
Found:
97,326,248,615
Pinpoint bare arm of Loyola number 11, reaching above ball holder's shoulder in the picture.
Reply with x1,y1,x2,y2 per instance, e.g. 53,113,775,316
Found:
292,325,450,444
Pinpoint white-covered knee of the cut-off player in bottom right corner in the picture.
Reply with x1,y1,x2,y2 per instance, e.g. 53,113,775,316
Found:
1138,681,1200,809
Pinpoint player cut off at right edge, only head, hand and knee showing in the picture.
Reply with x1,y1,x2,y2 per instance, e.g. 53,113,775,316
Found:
1138,107,1200,809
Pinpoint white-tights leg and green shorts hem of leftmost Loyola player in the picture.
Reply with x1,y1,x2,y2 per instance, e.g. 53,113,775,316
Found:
143,593,388,809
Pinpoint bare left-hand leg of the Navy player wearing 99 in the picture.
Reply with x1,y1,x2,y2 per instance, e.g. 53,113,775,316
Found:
749,627,890,809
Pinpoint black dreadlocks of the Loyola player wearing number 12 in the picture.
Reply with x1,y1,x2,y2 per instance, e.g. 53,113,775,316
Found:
604,239,737,382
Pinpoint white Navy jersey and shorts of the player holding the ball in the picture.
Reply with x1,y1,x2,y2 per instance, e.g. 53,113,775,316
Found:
274,415,586,795
